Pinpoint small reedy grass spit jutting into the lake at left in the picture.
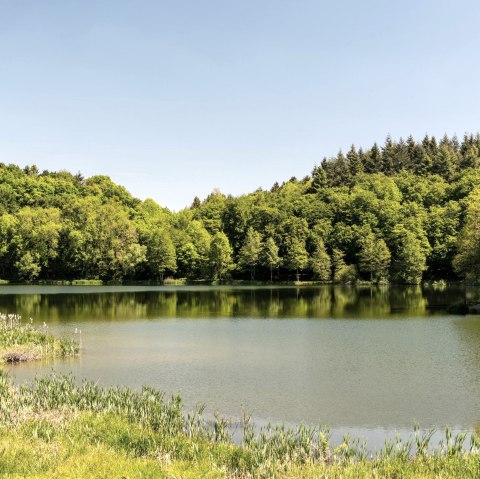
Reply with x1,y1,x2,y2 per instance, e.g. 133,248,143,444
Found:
0,313,78,364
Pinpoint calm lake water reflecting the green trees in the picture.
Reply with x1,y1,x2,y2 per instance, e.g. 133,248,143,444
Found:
0,286,480,443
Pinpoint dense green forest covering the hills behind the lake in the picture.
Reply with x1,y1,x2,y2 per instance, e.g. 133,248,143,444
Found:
0,134,480,284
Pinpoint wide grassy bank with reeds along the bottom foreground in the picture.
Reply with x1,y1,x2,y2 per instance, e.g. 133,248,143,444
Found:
0,373,480,479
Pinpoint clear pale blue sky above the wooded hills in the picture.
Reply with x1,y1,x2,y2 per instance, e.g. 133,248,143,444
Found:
0,0,480,210
